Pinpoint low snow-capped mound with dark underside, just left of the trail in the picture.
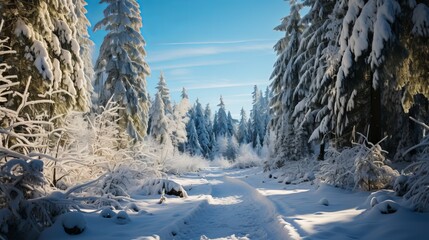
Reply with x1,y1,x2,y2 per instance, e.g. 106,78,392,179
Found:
141,179,188,198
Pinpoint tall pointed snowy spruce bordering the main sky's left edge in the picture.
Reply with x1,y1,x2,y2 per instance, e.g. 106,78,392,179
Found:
94,0,150,141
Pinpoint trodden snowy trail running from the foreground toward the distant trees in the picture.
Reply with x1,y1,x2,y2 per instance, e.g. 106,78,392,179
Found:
174,169,289,240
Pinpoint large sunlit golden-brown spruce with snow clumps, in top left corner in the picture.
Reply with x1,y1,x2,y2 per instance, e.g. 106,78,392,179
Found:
0,0,90,123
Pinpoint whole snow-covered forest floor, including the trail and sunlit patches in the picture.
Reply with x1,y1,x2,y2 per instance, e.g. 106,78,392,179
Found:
40,167,429,240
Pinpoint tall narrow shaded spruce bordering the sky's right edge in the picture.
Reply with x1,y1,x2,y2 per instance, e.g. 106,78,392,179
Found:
268,0,308,167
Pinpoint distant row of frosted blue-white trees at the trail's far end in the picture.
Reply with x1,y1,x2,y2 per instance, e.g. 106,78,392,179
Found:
148,73,270,160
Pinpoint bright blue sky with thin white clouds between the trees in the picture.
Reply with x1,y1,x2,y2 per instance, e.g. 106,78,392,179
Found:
87,0,289,118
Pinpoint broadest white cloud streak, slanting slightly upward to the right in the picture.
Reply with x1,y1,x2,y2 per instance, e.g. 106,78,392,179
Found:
147,43,273,63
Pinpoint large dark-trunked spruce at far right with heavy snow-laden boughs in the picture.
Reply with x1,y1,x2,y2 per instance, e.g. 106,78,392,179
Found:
314,0,428,153
